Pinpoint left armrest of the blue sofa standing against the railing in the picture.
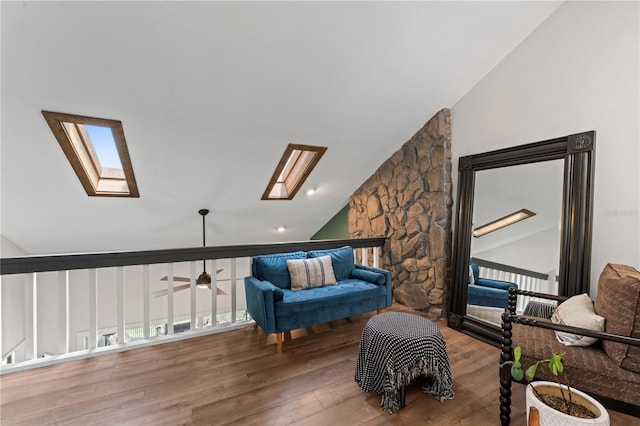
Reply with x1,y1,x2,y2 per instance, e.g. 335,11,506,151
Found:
244,277,283,334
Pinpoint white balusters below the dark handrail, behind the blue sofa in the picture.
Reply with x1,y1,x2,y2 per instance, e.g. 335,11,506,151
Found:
0,238,379,374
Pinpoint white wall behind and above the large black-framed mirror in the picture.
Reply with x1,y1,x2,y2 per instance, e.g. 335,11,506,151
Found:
452,2,640,296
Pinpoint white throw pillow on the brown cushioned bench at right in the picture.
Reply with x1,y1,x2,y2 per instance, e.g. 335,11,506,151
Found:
551,293,604,346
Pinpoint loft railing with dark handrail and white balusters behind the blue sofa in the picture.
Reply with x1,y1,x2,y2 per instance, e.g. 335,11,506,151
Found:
0,238,384,374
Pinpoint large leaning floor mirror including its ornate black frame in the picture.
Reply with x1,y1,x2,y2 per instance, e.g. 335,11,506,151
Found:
448,132,595,343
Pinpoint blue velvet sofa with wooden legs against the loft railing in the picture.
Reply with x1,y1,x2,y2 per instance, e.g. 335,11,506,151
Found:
244,247,392,353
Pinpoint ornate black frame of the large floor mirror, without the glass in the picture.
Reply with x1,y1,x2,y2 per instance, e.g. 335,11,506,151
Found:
448,131,596,344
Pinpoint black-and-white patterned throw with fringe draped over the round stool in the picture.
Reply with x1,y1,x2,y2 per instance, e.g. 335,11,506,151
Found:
355,312,454,414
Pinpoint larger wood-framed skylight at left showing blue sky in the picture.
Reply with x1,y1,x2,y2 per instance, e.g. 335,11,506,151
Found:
42,111,140,198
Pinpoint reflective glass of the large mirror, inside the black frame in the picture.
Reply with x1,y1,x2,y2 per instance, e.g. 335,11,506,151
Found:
466,160,564,326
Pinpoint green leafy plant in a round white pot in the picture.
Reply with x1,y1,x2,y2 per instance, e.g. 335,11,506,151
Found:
500,346,609,426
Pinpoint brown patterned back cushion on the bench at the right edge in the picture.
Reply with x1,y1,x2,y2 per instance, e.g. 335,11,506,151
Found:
594,263,640,373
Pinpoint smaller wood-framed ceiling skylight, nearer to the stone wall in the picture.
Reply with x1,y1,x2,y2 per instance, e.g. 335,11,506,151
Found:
262,143,327,200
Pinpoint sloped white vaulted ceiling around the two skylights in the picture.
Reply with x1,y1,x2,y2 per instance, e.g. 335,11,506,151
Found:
0,1,559,254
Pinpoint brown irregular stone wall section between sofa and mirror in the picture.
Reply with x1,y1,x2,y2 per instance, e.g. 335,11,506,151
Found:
349,109,453,318
